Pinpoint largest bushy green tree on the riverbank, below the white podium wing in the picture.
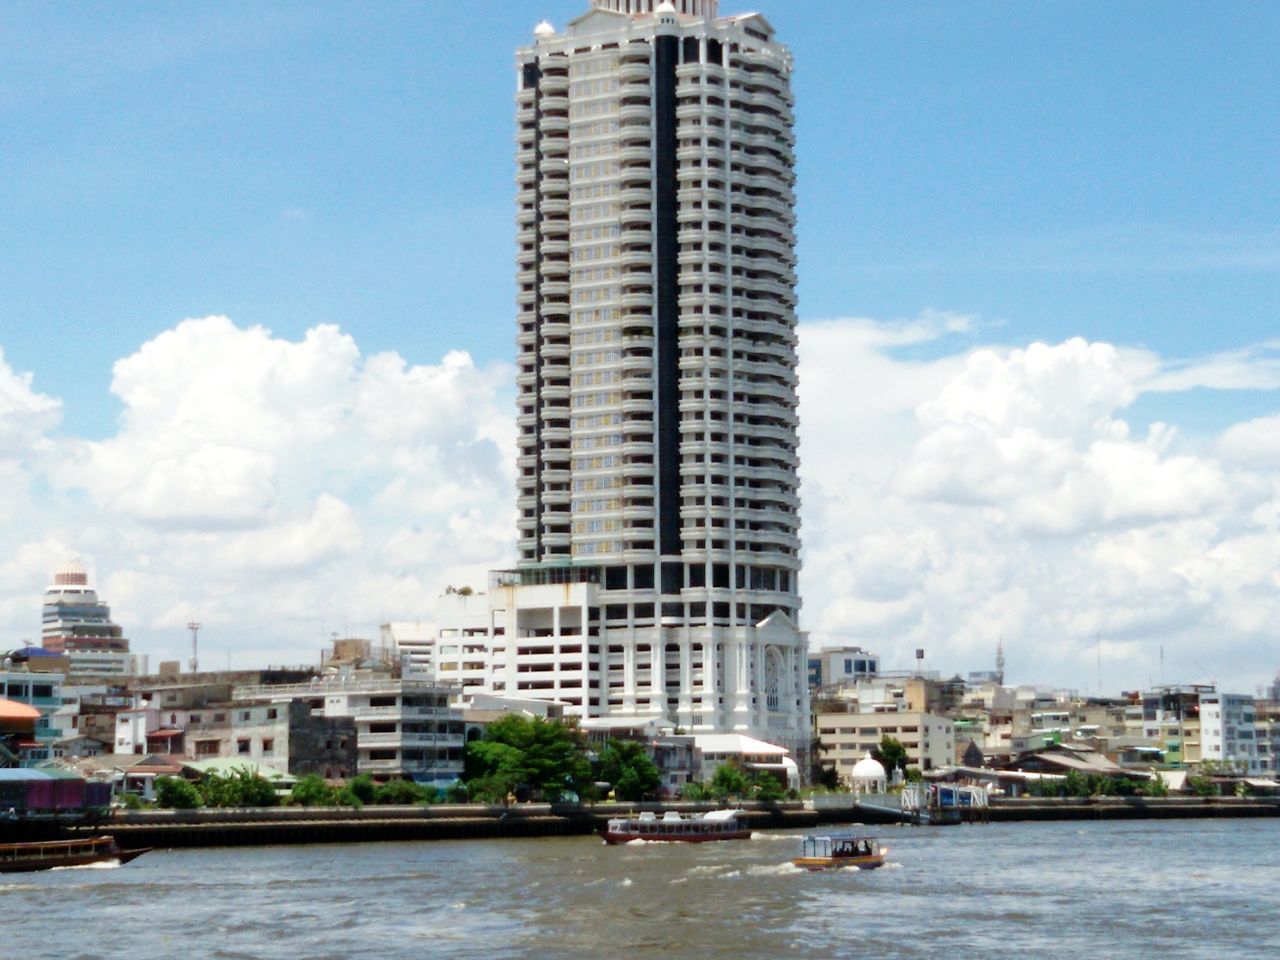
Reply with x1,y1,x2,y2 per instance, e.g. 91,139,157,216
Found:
463,714,591,803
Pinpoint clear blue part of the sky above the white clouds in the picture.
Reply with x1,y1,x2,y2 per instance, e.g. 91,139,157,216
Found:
0,0,1280,435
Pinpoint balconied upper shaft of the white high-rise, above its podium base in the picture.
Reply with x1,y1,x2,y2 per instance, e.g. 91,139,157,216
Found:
517,0,799,609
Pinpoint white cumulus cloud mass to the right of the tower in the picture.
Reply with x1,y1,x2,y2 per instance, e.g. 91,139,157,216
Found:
800,320,1280,692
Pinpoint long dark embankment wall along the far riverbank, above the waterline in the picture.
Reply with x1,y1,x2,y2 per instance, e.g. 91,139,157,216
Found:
49,797,1280,849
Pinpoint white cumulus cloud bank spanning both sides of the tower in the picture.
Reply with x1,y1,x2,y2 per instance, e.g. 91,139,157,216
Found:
0,312,1280,691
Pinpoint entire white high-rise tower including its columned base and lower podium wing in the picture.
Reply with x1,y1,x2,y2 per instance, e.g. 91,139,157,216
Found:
414,0,810,755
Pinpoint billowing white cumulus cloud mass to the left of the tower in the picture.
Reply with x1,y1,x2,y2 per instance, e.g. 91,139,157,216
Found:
0,317,515,664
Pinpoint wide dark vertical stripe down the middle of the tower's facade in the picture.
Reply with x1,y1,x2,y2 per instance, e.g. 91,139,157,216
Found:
653,36,681,557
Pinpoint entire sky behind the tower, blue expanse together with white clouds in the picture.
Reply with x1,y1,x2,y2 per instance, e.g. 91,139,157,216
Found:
0,0,1280,694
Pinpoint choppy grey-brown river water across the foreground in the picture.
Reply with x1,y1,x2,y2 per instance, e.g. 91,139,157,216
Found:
0,819,1280,960
